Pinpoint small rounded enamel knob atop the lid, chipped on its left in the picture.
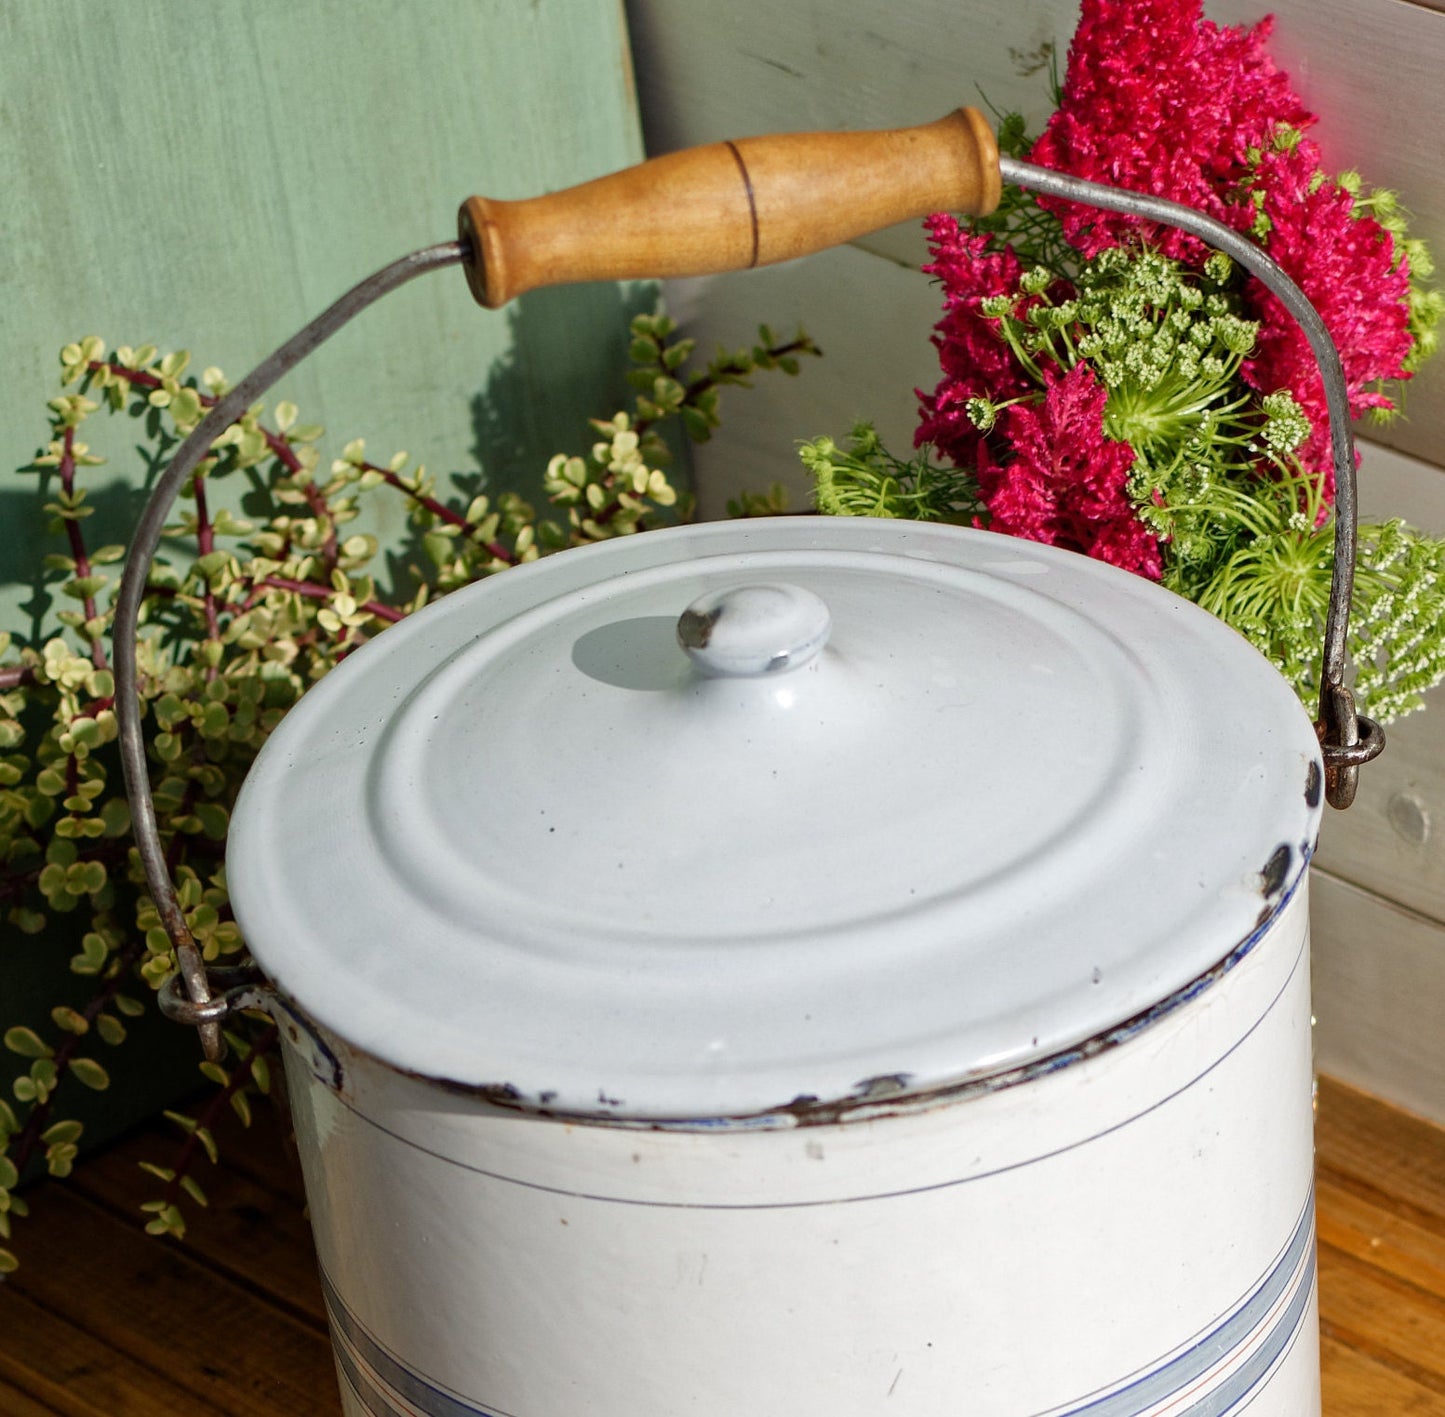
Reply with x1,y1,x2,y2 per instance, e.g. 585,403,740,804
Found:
678,585,832,677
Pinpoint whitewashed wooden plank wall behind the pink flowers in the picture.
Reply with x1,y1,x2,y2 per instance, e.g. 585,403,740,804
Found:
627,0,1445,1121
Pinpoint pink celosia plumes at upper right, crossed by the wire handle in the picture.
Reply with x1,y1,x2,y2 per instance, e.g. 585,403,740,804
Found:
1005,0,1412,501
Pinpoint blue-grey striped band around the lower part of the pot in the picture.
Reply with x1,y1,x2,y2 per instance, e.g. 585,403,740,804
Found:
321,1192,1315,1417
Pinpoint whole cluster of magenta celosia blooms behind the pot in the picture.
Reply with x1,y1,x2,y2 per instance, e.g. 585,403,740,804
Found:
918,0,1413,579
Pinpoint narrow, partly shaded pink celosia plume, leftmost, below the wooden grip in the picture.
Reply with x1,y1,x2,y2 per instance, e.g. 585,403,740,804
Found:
915,212,1033,468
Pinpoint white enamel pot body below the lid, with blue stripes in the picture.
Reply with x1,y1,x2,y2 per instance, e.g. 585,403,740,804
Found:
288,887,1319,1417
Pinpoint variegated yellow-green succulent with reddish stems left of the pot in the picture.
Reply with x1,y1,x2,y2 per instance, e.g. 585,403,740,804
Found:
0,315,818,1273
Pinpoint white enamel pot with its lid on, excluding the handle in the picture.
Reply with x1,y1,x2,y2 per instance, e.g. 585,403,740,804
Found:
227,519,1322,1417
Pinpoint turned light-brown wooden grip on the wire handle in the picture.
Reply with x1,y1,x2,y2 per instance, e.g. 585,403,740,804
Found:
461,108,1000,309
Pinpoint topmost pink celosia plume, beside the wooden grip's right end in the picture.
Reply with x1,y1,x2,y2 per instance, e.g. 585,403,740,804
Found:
1029,0,1315,261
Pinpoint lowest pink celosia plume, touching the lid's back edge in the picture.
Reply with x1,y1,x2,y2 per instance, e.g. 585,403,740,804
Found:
978,364,1163,581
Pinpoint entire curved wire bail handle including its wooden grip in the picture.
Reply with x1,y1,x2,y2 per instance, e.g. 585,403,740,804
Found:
113,108,1384,1059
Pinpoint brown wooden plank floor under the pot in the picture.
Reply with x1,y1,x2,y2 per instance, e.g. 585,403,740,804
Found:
0,1080,1445,1417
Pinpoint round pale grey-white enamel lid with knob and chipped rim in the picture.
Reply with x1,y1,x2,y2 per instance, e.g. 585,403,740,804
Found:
227,517,1321,1119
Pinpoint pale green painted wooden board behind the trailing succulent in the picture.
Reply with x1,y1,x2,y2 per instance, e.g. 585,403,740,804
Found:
0,0,650,1127
